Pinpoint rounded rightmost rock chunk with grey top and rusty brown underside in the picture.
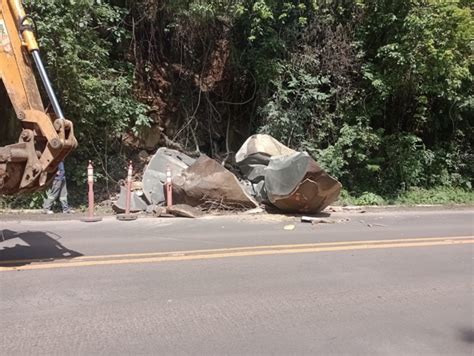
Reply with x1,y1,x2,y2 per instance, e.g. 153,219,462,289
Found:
265,152,342,213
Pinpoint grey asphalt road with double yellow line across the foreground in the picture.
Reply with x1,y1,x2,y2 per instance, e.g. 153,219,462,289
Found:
0,209,474,355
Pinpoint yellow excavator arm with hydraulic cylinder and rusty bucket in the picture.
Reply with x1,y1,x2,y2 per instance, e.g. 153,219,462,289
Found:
0,0,77,195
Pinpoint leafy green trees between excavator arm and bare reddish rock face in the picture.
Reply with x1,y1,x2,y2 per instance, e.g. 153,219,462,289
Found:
26,0,149,196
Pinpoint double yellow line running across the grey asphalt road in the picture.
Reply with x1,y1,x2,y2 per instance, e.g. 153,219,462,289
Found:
0,236,474,272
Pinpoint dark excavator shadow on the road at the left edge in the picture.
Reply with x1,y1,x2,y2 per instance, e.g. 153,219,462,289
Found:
0,229,82,267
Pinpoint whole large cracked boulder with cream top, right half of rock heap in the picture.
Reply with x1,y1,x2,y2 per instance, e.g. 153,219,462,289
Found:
235,135,341,213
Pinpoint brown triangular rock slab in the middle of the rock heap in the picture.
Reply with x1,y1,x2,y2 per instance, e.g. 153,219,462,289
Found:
173,156,258,209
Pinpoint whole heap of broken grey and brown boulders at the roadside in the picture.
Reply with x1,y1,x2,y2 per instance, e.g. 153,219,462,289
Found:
114,135,342,214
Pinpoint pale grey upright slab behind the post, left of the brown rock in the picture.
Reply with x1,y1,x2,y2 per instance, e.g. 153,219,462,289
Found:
142,147,195,204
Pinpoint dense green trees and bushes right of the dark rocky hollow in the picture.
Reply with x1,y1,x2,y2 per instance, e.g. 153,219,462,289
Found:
254,1,474,195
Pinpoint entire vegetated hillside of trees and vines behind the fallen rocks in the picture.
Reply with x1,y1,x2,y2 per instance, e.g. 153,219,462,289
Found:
4,0,474,204
